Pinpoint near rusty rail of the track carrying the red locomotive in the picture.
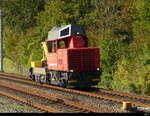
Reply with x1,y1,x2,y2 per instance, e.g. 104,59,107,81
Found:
0,73,150,108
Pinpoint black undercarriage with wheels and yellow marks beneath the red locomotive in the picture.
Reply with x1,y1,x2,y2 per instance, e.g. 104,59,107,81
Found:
30,68,100,88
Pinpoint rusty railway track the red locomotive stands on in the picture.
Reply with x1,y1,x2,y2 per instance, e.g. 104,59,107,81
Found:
0,73,150,112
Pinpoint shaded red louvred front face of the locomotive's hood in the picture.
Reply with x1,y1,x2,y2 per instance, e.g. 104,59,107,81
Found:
69,49,97,70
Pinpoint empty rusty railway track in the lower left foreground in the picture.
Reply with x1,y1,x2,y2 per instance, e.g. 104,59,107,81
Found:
0,72,102,113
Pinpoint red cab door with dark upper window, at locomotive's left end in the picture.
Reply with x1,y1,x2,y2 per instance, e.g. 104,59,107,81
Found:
47,41,57,70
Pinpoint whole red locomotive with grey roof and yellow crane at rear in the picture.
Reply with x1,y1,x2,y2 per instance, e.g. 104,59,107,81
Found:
30,24,100,87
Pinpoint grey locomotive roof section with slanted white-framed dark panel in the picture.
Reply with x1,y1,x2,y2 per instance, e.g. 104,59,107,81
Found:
48,24,85,40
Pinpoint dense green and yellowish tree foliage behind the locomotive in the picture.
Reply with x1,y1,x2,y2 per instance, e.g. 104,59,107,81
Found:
0,0,150,95
